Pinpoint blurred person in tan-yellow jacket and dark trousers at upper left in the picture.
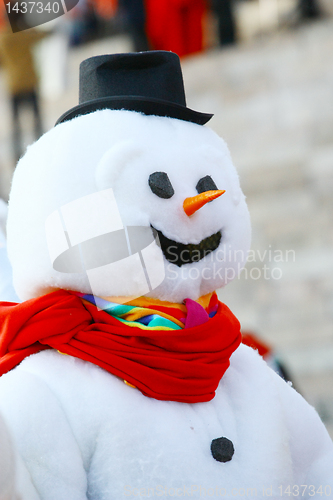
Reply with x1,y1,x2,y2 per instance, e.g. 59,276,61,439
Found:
0,2,46,162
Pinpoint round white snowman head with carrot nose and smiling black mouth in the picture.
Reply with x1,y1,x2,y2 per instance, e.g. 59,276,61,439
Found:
8,51,250,302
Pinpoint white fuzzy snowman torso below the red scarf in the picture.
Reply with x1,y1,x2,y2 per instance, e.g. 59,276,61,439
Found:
0,346,333,500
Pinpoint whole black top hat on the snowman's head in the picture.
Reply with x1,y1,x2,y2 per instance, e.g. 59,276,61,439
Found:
56,51,213,125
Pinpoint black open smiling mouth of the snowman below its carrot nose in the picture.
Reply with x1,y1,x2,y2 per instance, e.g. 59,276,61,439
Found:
151,226,222,267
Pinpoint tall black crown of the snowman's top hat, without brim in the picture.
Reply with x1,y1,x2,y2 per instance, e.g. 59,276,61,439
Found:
79,51,186,106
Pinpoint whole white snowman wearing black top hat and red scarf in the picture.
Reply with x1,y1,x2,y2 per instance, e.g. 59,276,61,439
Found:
0,51,333,500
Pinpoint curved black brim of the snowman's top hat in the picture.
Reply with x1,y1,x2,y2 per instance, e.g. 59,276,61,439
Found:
56,96,214,125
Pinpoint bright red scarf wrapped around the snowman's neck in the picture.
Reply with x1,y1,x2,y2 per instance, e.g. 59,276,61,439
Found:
0,290,241,403
